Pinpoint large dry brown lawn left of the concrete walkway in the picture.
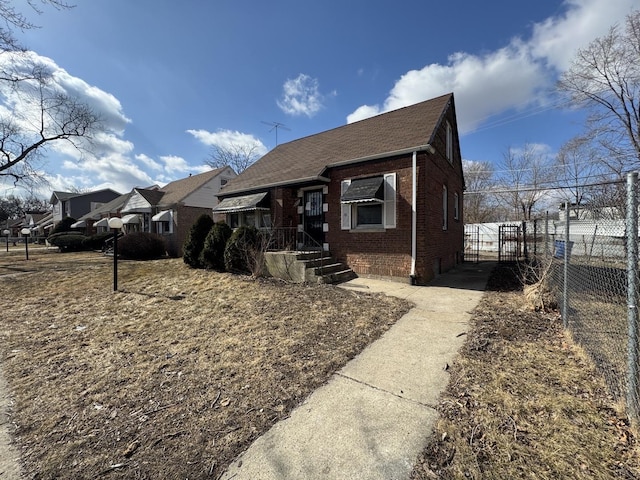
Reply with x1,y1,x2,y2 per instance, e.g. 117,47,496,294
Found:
0,251,410,479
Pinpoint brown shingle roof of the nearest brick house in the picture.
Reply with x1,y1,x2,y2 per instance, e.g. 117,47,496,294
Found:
221,93,453,196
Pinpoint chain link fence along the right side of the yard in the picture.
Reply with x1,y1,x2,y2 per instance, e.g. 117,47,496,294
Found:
524,174,640,423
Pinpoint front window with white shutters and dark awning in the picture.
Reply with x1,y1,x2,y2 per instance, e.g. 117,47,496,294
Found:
340,173,396,230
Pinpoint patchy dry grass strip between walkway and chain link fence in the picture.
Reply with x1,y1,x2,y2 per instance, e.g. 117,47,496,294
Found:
412,268,640,480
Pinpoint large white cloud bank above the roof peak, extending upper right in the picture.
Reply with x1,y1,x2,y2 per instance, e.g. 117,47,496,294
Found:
347,0,637,133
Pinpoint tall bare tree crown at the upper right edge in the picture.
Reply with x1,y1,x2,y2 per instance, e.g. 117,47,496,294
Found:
558,10,640,174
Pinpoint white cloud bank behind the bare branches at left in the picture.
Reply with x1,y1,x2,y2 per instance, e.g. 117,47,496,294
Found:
0,52,210,197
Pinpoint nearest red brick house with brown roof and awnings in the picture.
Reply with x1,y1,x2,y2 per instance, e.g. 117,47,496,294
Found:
214,94,464,284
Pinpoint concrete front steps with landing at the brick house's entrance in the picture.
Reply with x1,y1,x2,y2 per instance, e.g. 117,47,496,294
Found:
265,251,357,284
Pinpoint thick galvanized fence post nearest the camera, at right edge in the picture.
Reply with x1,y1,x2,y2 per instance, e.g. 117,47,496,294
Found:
626,172,638,422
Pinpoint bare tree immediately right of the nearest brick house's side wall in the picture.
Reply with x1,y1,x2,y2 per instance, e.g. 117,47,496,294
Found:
462,161,496,223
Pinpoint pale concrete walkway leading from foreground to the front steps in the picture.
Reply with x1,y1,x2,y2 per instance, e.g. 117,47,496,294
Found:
222,263,495,480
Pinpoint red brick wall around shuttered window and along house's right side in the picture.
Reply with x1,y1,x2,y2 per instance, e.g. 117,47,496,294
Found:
325,112,464,284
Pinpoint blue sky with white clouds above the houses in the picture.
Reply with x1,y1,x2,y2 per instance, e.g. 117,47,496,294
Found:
0,0,640,197
